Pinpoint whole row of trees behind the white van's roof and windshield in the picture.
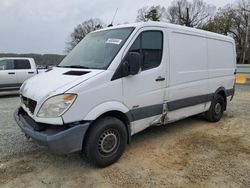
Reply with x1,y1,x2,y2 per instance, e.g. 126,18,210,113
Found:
66,0,250,63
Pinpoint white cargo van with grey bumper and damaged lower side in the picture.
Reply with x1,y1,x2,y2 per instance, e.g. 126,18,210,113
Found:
14,22,236,167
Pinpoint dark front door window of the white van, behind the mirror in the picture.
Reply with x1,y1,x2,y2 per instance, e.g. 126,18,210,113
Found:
129,31,163,70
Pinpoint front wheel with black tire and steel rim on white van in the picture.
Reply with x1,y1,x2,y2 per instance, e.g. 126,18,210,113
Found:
83,117,127,167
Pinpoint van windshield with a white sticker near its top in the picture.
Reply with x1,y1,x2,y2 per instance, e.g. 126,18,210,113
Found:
58,27,134,69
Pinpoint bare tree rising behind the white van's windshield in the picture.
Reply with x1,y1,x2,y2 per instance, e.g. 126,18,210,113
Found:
66,18,105,52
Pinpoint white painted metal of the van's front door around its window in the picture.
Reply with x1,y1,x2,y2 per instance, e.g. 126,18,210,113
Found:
122,27,167,106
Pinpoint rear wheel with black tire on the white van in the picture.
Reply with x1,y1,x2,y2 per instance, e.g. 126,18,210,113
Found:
205,95,226,122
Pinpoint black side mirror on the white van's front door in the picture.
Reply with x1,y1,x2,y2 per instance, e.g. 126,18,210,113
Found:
123,52,141,76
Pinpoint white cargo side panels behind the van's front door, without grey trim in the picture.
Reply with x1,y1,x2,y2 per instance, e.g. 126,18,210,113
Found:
162,25,236,123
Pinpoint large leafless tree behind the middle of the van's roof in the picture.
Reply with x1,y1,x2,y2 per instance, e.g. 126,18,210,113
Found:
167,0,216,27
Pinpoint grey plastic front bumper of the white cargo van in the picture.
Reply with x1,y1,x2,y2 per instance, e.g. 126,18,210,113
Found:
14,108,90,154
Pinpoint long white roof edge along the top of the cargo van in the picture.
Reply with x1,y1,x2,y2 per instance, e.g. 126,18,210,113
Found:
94,21,234,42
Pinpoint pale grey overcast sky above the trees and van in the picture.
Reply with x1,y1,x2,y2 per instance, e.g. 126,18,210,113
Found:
0,0,234,54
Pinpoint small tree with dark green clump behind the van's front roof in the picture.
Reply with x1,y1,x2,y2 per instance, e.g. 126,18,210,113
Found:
136,5,166,22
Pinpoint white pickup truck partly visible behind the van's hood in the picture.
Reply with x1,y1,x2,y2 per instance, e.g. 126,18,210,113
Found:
0,57,38,91
